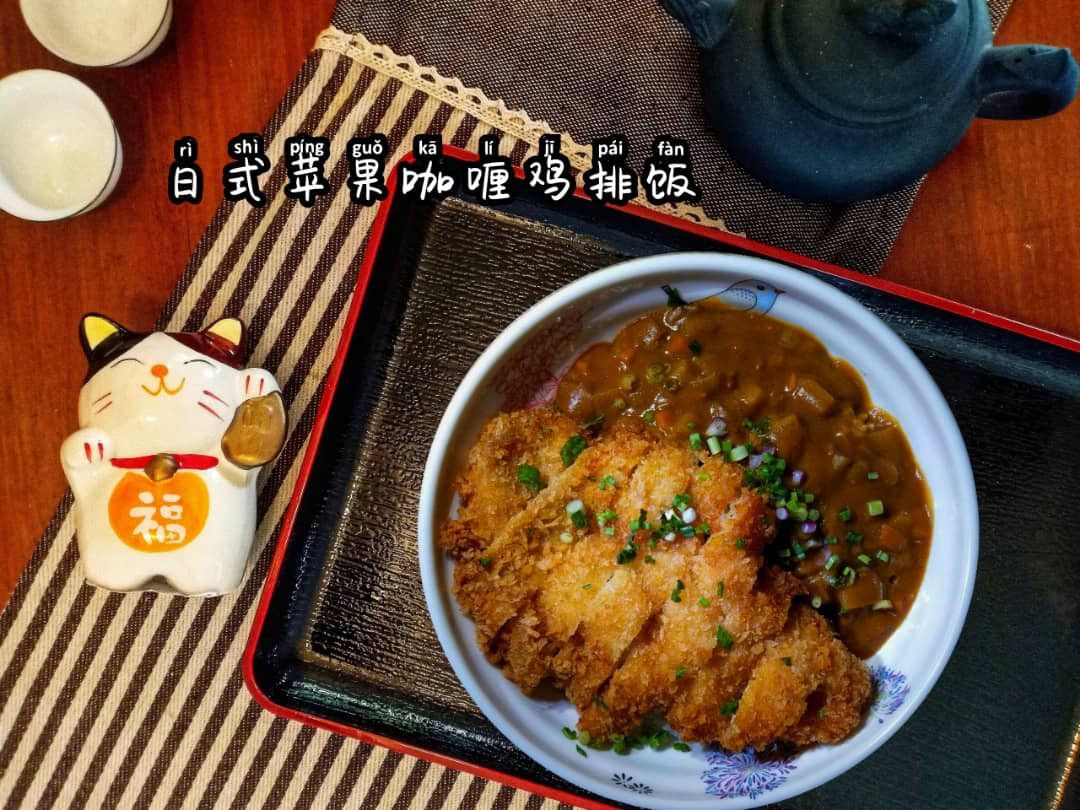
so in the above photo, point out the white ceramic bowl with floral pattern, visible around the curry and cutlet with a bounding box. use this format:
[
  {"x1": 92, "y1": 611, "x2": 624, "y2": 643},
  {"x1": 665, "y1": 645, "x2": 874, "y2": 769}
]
[{"x1": 419, "y1": 253, "x2": 978, "y2": 810}]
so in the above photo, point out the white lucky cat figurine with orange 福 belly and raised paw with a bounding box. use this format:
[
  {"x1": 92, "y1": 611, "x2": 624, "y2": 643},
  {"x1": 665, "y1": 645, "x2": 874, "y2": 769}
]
[{"x1": 60, "y1": 313, "x2": 285, "y2": 596}]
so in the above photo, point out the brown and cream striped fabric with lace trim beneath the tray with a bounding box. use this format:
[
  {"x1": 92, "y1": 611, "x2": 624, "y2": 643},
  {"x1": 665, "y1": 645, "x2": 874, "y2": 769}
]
[{"x1": 0, "y1": 29, "x2": 665, "y2": 810}]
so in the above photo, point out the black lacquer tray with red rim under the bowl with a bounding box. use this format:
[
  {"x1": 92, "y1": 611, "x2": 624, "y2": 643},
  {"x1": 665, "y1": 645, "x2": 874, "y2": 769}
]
[{"x1": 244, "y1": 149, "x2": 1080, "y2": 810}]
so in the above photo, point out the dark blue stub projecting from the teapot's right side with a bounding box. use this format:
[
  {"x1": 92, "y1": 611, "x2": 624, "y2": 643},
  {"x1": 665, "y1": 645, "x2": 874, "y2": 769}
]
[{"x1": 975, "y1": 45, "x2": 1080, "y2": 119}]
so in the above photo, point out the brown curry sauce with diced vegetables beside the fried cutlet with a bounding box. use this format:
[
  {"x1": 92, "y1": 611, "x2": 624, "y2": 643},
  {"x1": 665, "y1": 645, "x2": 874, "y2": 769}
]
[{"x1": 555, "y1": 296, "x2": 933, "y2": 658}]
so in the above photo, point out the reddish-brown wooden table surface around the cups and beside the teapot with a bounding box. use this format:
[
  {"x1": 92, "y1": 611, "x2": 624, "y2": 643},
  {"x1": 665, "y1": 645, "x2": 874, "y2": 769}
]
[{"x1": 0, "y1": 0, "x2": 1080, "y2": 605}]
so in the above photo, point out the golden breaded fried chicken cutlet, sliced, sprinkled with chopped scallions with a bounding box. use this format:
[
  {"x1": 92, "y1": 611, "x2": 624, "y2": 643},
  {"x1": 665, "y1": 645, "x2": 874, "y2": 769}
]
[{"x1": 441, "y1": 408, "x2": 870, "y2": 750}]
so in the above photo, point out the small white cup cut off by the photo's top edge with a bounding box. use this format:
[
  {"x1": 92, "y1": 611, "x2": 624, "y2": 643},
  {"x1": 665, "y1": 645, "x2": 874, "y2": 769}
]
[{"x1": 19, "y1": 0, "x2": 173, "y2": 67}]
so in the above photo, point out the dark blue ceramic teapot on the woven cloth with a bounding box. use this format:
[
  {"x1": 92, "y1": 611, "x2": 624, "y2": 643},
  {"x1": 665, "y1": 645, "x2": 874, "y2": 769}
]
[{"x1": 663, "y1": 0, "x2": 1078, "y2": 202}]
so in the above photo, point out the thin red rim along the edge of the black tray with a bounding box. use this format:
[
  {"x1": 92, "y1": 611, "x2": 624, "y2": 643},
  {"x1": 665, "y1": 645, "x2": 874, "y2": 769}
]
[{"x1": 241, "y1": 145, "x2": 1080, "y2": 810}]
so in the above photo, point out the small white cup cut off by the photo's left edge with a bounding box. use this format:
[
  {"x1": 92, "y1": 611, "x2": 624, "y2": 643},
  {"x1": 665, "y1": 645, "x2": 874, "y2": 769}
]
[{"x1": 0, "y1": 70, "x2": 123, "y2": 221}]
